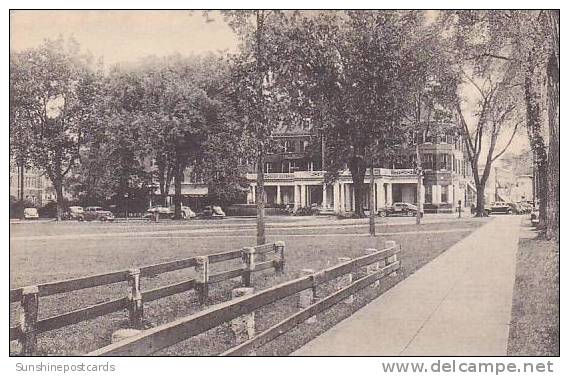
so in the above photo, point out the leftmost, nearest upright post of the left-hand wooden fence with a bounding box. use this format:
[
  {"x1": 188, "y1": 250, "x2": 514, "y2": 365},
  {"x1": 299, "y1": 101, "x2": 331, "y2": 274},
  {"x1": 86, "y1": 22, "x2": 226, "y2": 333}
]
[{"x1": 19, "y1": 286, "x2": 39, "y2": 356}]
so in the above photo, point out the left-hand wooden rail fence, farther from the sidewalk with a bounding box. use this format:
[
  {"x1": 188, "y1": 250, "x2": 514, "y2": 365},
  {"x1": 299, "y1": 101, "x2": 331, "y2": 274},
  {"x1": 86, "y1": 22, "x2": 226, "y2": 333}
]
[{"x1": 9, "y1": 241, "x2": 285, "y2": 355}]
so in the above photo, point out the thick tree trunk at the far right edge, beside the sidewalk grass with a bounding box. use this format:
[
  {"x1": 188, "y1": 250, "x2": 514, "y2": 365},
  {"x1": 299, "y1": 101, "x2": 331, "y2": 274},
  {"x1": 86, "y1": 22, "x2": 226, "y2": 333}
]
[{"x1": 540, "y1": 50, "x2": 560, "y2": 240}]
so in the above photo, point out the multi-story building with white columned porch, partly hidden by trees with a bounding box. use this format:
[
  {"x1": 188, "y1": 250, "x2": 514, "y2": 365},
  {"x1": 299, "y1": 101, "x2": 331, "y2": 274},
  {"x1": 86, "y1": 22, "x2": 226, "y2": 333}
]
[{"x1": 242, "y1": 122, "x2": 476, "y2": 212}]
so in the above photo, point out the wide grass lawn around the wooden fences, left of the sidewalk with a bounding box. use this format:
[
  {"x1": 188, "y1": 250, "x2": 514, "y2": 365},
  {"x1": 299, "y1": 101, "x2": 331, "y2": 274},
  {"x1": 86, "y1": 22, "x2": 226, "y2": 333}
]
[{"x1": 10, "y1": 219, "x2": 488, "y2": 355}]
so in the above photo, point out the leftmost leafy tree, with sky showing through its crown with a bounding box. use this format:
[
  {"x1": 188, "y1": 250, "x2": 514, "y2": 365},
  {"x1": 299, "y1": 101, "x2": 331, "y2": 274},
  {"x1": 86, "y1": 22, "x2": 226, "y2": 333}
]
[{"x1": 10, "y1": 38, "x2": 98, "y2": 219}]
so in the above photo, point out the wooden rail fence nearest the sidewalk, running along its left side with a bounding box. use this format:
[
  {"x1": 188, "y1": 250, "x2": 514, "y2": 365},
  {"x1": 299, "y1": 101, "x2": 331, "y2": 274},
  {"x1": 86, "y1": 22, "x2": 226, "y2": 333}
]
[{"x1": 86, "y1": 242, "x2": 401, "y2": 356}]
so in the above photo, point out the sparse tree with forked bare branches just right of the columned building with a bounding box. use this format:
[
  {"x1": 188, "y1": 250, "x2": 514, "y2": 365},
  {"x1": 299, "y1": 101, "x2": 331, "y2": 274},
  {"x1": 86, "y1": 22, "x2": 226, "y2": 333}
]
[{"x1": 446, "y1": 11, "x2": 523, "y2": 216}]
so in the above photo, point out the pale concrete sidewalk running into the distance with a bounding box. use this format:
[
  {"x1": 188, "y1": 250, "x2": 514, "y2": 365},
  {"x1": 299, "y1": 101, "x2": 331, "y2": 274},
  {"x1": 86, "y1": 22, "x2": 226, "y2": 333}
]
[{"x1": 291, "y1": 216, "x2": 520, "y2": 356}]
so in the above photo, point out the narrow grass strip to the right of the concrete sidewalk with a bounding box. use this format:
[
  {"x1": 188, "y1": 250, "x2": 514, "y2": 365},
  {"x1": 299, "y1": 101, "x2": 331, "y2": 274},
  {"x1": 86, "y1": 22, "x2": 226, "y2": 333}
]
[{"x1": 508, "y1": 222, "x2": 560, "y2": 356}]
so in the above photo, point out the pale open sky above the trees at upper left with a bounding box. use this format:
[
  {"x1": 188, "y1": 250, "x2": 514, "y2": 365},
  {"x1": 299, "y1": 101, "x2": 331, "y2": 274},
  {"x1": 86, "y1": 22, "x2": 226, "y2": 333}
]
[{"x1": 10, "y1": 10, "x2": 238, "y2": 66}]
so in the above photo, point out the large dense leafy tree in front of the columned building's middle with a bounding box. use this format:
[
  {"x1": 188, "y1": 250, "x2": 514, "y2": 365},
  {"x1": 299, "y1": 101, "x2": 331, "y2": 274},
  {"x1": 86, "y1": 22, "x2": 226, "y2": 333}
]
[{"x1": 278, "y1": 11, "x2": 408, "y2": 216}]
